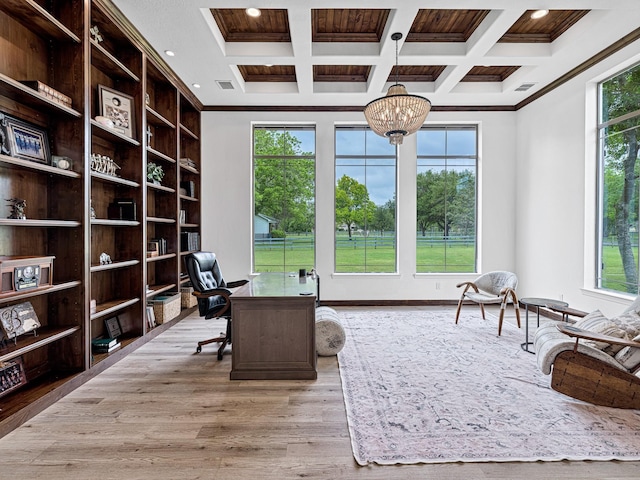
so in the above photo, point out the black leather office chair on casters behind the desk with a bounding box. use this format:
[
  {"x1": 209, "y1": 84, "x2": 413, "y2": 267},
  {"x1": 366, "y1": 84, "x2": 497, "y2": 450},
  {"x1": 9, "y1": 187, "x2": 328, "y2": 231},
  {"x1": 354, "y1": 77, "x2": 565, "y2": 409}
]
[{"x1": 184, "y1": 252, "x2": 249, "y2": 360}]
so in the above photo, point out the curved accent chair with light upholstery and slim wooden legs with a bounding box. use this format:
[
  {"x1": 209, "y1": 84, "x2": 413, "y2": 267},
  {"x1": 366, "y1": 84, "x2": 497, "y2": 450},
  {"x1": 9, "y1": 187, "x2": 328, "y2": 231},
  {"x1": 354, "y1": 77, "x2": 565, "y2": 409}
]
[{"x1": 456, "y1": 270, "x2": 520, "y2": 335}]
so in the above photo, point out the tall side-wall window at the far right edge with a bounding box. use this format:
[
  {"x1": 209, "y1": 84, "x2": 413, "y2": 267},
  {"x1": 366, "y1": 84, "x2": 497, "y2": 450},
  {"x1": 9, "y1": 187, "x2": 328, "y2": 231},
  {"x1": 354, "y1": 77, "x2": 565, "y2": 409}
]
[{"x1": 596, "y1": 65, "x2": 640, "y2": 294}]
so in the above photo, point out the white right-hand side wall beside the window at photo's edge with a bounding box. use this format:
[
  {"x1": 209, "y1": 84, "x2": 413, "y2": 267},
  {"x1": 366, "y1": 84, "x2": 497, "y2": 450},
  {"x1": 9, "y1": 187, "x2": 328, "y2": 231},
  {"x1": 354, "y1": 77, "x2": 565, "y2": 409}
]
[{"x1": 515, "y1": 42, "x2": 640, "y2": 315}]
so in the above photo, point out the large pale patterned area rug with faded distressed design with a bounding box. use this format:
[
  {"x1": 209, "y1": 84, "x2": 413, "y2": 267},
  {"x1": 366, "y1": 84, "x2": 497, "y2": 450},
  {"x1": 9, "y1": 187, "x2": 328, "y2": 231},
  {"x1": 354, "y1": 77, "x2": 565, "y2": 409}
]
[{"x1": 338, "y1": 309, "x2": 640, "y2": 465}]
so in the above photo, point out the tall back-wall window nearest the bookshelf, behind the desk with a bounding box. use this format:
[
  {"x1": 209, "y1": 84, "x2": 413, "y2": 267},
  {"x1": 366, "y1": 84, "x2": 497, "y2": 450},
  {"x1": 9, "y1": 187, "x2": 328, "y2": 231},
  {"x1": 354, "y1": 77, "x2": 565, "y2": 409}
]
[{"x1": 253, "y1": 126, "x2": 316, "y2": 272}]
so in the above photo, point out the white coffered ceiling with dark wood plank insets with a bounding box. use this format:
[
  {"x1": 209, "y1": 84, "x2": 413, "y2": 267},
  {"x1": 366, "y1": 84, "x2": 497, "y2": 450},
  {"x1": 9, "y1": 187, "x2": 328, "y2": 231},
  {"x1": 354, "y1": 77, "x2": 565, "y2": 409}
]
[{"x1": 113, "y1": 0, "x2": 640, "y2": 109}]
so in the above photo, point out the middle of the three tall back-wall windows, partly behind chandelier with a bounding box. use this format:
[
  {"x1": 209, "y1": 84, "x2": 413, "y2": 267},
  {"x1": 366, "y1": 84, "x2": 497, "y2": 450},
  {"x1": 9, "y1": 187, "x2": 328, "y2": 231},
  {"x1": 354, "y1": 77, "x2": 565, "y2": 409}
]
[{"x1": 335, "y1": 127, "x2": 396, "y2": 273}]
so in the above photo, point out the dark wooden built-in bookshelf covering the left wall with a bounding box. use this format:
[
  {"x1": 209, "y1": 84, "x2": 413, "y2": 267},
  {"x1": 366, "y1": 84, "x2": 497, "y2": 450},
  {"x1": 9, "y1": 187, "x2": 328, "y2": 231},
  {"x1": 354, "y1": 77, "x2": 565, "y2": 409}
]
[{"x1": 0, "y1": 0, "x2": 202, "y2": 436}]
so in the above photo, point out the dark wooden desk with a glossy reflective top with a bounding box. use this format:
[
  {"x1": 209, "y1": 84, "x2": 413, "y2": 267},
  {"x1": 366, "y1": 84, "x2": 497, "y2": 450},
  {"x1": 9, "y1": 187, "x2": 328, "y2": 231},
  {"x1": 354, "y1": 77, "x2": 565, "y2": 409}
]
[{"x1": 230, "y1": 273, "x2": 318, "y2": 380}]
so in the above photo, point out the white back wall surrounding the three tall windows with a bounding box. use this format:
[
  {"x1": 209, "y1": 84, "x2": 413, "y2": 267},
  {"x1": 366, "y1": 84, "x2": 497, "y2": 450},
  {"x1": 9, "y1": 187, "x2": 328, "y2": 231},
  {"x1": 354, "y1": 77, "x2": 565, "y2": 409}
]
[{"x1": 202, "y1": 111, "x2": 518, "y2": 300}]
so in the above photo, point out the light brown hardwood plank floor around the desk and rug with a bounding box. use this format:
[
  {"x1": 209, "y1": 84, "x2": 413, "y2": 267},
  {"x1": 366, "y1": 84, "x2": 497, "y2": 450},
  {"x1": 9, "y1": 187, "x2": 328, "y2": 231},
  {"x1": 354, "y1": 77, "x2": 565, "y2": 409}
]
[{"x1": 0, "y1": 309, "x2": 640, "y2": 480}]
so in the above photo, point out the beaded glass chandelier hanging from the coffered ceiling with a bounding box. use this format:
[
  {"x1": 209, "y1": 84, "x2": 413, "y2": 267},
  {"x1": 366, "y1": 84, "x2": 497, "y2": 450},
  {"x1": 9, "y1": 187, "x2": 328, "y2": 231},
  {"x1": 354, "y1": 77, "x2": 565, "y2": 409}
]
[{"x1": 364, "y1": 33, "x2": 431, "y2": 145}]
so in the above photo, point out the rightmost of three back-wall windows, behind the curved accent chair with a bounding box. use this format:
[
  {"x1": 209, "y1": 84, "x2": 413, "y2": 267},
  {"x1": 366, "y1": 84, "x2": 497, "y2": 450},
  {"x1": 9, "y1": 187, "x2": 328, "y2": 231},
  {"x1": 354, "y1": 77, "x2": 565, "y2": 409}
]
[{"x1": 416, "y1": 126, "x2": 478, "y2": 273}]
